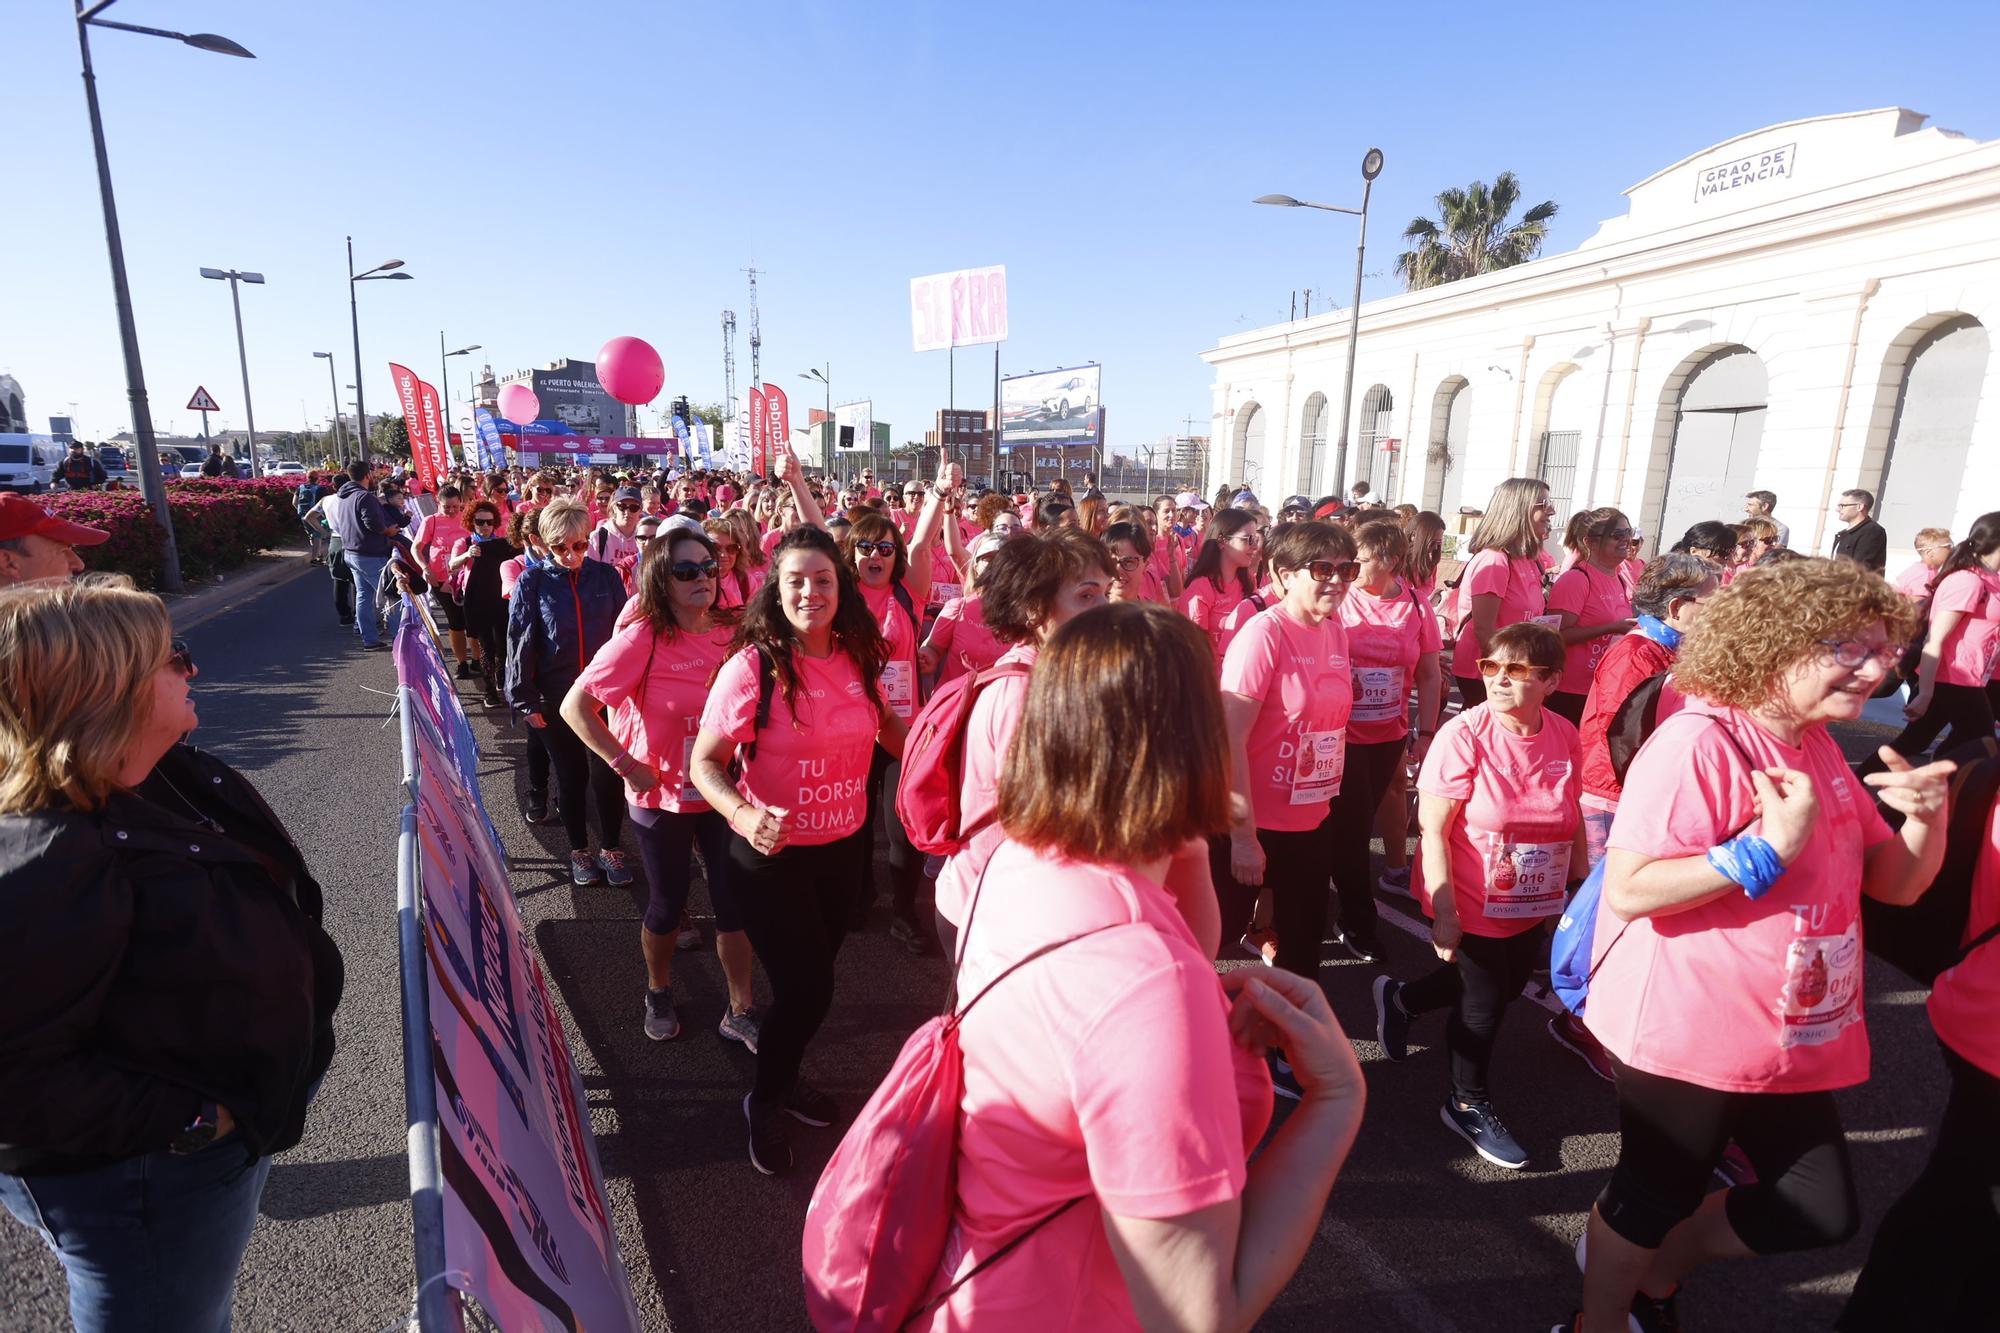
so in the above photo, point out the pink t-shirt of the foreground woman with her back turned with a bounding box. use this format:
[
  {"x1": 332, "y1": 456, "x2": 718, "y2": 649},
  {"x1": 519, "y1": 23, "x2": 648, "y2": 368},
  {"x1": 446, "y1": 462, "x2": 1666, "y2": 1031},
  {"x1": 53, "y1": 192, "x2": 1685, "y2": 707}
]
[{"x1": 918, "y1": 843, "x2": 1272, "y2": 1333}]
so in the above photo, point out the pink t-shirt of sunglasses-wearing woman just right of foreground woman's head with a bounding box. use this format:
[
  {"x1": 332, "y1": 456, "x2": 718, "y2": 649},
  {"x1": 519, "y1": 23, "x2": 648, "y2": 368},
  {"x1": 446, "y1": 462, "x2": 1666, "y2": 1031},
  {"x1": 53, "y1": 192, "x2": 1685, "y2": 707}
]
[{"x1": 1222, "y1": 606, "x2": 1354, "y2": 833}]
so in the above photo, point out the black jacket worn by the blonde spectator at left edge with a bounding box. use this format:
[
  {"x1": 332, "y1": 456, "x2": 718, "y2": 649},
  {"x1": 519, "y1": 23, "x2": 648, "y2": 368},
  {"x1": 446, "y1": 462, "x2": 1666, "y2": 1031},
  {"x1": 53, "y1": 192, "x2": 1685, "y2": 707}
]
[{"x1": 0, "y1": 745, "x2": 342, "y2": 1173}]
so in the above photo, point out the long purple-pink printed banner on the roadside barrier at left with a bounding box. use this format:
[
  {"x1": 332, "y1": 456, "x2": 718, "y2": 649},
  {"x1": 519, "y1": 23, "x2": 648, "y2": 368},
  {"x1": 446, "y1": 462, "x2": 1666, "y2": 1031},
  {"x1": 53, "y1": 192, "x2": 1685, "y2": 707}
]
[{"x1": 396, "y1": 616, "x2": 640, "y2": 1333}]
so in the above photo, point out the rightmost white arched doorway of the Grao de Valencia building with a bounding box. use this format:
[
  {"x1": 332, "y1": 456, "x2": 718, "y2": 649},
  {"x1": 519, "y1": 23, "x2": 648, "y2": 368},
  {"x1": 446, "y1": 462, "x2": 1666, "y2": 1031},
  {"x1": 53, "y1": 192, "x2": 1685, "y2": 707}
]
[{"x1": 1876, "y1": 314, "x2": 1990, "y2": 546}]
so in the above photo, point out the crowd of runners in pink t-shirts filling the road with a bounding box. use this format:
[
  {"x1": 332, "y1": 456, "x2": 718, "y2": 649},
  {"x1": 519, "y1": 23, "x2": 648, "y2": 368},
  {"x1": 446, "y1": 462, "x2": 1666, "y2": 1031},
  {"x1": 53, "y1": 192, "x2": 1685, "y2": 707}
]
[{"x1": 0, "y1": 454, "x2": 2000, "y2": 1333}]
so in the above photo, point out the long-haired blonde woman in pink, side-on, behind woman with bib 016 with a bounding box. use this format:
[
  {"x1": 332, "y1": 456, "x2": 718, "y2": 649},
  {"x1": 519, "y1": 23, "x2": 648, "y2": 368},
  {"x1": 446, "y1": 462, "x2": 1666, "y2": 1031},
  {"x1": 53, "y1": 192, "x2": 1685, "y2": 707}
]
[{"x1": 1452, "y1": 476, "x2": 1558, "y2": 709}]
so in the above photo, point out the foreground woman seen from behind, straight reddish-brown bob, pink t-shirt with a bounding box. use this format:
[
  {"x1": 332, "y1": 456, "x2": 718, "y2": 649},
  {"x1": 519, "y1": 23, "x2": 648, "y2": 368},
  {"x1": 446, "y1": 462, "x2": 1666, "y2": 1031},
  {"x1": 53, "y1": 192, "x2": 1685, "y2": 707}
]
[{"x1": 914, "y1": 602, "x2": 1364, "y2": 1333}]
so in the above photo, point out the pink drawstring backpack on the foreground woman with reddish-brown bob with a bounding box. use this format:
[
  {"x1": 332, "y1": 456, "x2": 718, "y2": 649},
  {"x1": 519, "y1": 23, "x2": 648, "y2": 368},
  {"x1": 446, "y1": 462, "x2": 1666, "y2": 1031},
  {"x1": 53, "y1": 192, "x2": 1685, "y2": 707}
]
[{"x1": 802, "y1": 868, "x2": 1130, "y2": 1333}]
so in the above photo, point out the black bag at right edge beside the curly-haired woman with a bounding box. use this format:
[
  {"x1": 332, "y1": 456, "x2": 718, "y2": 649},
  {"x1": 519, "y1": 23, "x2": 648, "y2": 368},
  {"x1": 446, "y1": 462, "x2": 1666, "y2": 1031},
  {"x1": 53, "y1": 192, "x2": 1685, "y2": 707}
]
[{"x1": 1862, "y1": 737, "x2": 2000, "y2": 987}]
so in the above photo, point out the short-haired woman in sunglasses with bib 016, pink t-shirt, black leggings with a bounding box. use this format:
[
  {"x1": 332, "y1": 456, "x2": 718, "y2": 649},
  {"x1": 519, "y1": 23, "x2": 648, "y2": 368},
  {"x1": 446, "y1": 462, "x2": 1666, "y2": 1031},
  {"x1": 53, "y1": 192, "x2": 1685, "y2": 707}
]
[{"x1": 1374, "y1": 622, "x2": 1584, "y2": 1171}]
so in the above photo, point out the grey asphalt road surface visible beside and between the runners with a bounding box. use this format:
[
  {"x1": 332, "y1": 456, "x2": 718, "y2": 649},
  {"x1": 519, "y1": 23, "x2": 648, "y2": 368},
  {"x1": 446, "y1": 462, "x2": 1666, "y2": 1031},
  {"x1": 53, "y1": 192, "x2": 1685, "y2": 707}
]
[{"x1": 0, "y1": 574, "x2": 1944, "y2": 1333}]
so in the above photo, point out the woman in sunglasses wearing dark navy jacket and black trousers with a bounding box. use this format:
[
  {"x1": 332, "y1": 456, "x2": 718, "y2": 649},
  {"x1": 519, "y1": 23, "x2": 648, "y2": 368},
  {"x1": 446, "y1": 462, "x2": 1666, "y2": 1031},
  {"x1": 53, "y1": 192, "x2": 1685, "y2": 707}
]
[{"x1": 506, "y1": 500, "x2": 632, "y2": 889}]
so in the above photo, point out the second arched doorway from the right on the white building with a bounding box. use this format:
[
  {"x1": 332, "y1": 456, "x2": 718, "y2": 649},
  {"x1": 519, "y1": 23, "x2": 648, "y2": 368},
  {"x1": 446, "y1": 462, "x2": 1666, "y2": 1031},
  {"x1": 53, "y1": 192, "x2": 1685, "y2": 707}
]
[{"x1": 1654, "y1": 346, "x2": 1770, "y2": 550}]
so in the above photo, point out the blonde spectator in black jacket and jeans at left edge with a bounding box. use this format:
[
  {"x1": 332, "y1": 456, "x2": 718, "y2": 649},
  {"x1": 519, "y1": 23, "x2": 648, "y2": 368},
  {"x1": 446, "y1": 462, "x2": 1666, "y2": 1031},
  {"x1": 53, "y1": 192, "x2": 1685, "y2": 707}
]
[{"x1": 0, "y1": 574, "x2": 342, "y2": 1333}]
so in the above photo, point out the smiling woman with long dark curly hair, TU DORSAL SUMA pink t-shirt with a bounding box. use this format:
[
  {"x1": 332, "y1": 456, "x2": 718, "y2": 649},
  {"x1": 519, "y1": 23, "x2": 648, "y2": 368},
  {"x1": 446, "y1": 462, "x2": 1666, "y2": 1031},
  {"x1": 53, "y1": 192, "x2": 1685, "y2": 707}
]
[{"x1": 688, "y1": 520, "x2": 904, "y2": 1175}]
